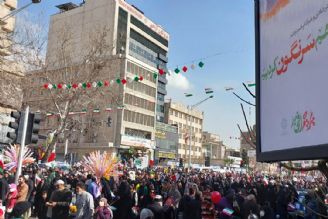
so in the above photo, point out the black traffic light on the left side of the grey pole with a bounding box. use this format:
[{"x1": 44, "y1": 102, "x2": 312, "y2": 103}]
[{"x1": 7, "y1": 111, "x2": 25, "y2": 144}]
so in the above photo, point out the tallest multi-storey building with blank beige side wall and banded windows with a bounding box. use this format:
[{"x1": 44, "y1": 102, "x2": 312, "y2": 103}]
[{"x1": 23, "y1": 0, "x2": 169, "y2": 159}]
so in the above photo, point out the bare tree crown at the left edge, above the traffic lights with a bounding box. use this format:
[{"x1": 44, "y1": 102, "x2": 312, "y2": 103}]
[{"x1": 0, "y1": 14, "x2": 46, "y2": 110}]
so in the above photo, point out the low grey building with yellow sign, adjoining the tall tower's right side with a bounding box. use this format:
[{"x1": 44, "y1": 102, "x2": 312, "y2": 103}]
[{"x1": 155, "y1": 122, "x2": 179, "y2": 165}]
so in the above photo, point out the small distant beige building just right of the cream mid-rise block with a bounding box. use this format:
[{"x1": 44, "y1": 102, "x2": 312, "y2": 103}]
[{"x1": 202, "y1": 132, "x2": 226, "y2": 165}]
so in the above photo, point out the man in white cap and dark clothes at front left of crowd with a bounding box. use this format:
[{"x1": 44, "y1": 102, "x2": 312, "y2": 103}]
[{"x1": 46, "y1": 179, "x2": 72, "y2": 219}]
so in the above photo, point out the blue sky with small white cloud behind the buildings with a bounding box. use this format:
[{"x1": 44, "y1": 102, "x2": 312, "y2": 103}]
[{"x1": 19, "y1": 0, "x2": 255, "y2": 148}]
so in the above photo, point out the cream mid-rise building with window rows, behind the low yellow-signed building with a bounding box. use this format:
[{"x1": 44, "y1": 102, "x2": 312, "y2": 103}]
[{"x1": 164, "y1": 100, "x2": 204, "y2": 163}]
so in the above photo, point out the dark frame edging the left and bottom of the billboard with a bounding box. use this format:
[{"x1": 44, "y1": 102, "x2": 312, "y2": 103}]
[{"x1": 254, "y1": 0, "x2": 328, "y2": 162}]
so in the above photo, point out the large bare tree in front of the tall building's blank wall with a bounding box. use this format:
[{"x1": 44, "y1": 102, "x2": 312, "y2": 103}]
[{"x1": 25, "y1": 23, "x2": 123, "y2": 162}]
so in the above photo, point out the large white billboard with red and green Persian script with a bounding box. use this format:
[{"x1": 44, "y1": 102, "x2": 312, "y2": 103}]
[{"x1": 255, "y1": 0, "x2": 328, "y2": 161}]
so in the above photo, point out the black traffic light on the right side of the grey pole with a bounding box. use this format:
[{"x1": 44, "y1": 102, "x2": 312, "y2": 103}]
[{"x1": 25, "y1": 113, "x2": 41, "y2": 144}]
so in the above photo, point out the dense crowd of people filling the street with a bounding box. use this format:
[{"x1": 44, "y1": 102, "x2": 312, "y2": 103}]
[{"x1": 0, "y1": 164, "x2": 327, "y2": 219}]
